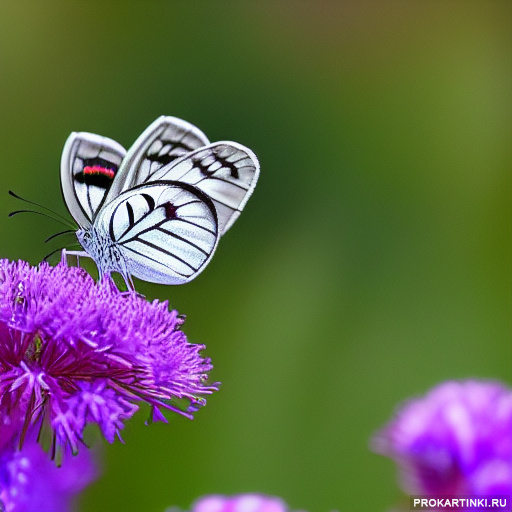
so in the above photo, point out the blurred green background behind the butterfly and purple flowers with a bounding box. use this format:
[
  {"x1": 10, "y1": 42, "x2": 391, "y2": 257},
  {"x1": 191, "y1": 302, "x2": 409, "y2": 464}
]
[{"x1": 0, "y1": 0, "x2": 512, "y2": 512}]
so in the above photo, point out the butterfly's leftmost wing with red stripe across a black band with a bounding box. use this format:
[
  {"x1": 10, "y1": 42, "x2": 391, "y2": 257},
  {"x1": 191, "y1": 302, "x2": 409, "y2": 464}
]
[{"x1": 60, "y1": 132, "x2": 126, "y2": 227}]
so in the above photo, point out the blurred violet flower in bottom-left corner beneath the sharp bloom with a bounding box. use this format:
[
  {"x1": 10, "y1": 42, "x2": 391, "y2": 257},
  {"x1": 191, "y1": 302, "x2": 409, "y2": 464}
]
[{"x1": 0, "y1": 428, "x2": 97, "y2": 512}]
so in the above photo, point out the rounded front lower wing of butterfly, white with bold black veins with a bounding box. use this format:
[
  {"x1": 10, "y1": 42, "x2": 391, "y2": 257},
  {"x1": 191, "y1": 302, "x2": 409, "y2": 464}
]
[{"x1": 94, "y1": 182, "x2": 219, "y2": 284}]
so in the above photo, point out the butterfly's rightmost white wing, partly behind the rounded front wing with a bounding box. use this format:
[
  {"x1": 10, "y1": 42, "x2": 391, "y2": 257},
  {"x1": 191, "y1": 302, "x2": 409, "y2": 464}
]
[{"x1": 150, "y1": 142, "x2": 260, "y2": 235}]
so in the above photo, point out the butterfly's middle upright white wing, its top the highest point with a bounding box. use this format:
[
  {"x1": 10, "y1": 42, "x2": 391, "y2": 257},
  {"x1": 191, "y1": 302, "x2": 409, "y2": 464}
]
[{"x1": 107, "y1": 116, "x2": 209, "y2": 201}]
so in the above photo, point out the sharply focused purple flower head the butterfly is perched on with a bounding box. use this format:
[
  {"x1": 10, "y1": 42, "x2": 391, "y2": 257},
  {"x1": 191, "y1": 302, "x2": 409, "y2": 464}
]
[{"x1": 0, "y1": 260, "x2": 217, "y2": 453}]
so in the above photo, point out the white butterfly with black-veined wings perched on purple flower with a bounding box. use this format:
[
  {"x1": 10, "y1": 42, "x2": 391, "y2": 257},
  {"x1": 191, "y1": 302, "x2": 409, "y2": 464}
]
[{"x1": 61, "y1": 116, "x2": 259, "y2": 290}]
